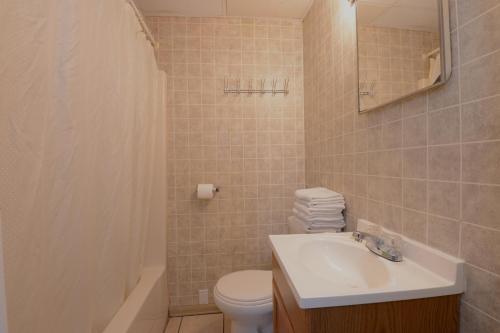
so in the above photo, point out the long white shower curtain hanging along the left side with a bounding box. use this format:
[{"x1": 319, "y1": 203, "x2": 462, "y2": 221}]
[{"x1": 0, "y1": 0, "x2": 166, "y2": 333}]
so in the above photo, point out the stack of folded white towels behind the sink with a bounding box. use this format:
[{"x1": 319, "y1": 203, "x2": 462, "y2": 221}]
[{"x1": 293, "y1": 187, "x2": 345, "y2": 231}]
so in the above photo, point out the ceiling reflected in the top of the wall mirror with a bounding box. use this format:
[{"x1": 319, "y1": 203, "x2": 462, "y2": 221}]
[{"x1": 357, "y1": 0, "x2": 438, "y2": 32}]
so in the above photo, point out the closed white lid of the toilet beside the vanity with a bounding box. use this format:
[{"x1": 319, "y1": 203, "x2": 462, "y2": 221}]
[{"x1": 216, "y1": 270, "x2": 273, "y2": 302}]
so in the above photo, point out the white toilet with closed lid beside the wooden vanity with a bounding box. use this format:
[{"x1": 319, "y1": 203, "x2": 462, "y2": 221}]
[{"x1": 214, "y1": 270, "x2": 273, "y2": 333}]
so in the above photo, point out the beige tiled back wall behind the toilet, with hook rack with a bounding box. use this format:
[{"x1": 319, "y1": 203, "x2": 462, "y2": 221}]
[{"x1": 147, "y1": 17, "x2": 305, "y2": 305}]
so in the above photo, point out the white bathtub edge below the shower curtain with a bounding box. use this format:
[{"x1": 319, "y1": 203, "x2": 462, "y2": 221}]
[{"x1": 103, "y1": 266, "x2": 168, "y2": 333}]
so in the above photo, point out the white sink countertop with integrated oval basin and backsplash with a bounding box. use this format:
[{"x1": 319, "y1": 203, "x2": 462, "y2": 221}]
[{"x1": 269, "y1": 220, "x2": 465, "y2": 309}]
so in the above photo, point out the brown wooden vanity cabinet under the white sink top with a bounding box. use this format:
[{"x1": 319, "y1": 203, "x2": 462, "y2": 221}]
[{"x1": 273, "y1": 256, "x2": 460, "y2": 333}]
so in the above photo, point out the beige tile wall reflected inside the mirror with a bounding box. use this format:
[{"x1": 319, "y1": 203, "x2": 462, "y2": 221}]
[{"x1": 358, "y1": 26, "x2": 439, "y2": 110}]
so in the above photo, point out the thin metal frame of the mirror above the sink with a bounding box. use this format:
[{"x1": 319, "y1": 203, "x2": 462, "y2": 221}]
[{"x1": 355, "y1": 0, "x2": 452, "y2": 113}]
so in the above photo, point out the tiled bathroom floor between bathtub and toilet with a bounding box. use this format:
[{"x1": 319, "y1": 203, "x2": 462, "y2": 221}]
[{"x1": 165, "y1": 313, "x2": 229, "y2": 333}]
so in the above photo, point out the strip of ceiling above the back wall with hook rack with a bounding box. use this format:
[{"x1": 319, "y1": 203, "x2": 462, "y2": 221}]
[{"x1": 135, "y1": 0, "x2": 313, "y2": 18}]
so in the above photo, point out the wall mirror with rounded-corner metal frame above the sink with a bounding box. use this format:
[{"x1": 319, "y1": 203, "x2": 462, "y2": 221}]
[{"x1": 356, "y1": 0, "x2": 451, "y2": 112}]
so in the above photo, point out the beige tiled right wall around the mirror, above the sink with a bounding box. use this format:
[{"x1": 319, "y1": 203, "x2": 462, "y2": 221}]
[{"x1": 304, "y1": 0, "x2": 500, "y2": 333}]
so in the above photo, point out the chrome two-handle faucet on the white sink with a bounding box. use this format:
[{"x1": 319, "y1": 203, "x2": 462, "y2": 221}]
[{"x1": 352, "y1": 230, "x2": 403, "y2": 262}]
